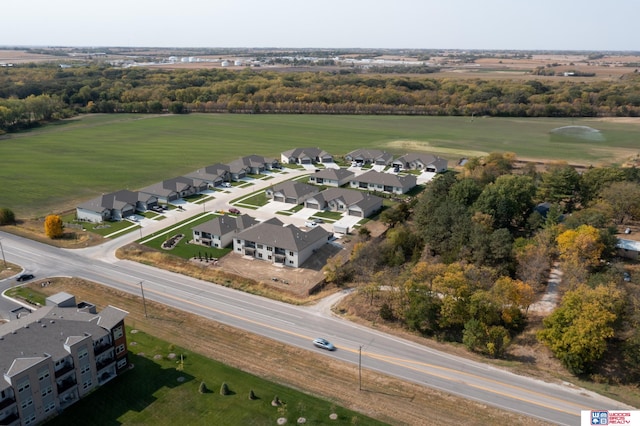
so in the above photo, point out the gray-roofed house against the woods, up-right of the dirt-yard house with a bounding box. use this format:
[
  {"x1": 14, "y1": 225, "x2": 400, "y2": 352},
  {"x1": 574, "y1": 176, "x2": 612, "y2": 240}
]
[{"x1": 304, "y1": 188, "x2": 382, "y2": 218}]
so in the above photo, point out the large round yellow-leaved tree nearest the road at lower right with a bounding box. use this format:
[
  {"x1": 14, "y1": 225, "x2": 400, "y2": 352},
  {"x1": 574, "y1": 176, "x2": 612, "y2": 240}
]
[{"x1": 537, "y1": 284, "x2": 623, "y2": 374}]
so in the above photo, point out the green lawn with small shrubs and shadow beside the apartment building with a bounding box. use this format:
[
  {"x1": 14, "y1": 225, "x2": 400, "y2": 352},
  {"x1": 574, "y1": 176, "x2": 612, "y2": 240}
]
[{"x1": 47, "y1": 329, "x2": 384, "y2": 426}]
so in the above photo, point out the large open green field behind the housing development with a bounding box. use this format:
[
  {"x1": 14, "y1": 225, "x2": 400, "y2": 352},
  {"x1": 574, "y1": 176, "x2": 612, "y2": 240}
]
[{"x1": 0, "y1": 114, "x2": 640, "y2": 217}]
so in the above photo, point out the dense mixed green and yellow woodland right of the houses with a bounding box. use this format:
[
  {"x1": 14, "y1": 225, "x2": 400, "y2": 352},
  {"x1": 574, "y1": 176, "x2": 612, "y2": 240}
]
[{"x1": 326, "y1": 153, "x2": 640, "y2": 381}]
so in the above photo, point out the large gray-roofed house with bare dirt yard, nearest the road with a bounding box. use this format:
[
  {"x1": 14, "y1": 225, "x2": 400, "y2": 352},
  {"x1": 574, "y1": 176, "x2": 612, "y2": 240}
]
[{"x1": 233, "y1": 218, "x2": 332, "y2": 268}]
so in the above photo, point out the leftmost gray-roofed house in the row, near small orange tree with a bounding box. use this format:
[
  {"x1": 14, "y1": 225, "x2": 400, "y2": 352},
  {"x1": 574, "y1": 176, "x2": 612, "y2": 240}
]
[{"x1": 76, "y1": 189, "x2": 158, "y2": 223}]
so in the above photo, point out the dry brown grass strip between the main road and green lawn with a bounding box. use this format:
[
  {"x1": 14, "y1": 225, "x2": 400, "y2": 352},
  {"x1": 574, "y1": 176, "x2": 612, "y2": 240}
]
[{"x1": 21, "y1": 278, "x2": 542, "y2": 425}]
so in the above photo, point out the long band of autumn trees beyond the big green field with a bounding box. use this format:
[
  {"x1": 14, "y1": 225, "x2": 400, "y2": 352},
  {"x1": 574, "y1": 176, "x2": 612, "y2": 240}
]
[{"x1": 0, "y1": 64, "x2": 640, "y2": 132}]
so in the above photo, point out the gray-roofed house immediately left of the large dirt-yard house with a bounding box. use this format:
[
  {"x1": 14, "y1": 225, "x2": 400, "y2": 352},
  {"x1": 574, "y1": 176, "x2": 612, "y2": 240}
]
[{"x1": 191, "y1": 214, "x2": 258, "y2": 248}]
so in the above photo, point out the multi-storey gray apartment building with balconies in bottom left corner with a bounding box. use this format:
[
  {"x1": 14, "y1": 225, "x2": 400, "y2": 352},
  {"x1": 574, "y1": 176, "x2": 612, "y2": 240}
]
[{"x1": 0, "y1": 293, "x2": 129, "y2": 426}]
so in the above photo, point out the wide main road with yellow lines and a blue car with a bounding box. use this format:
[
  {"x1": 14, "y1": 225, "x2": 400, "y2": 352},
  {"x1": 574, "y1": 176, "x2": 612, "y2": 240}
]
[{"x1": 0, "y1": 232, "x2": 629, "y2": 425}]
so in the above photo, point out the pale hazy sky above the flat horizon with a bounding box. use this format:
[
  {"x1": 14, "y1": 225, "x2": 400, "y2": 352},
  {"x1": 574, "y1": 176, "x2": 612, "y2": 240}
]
[{"x1": 0, "y1": 0, "x2": 640, "y2": 51}]
